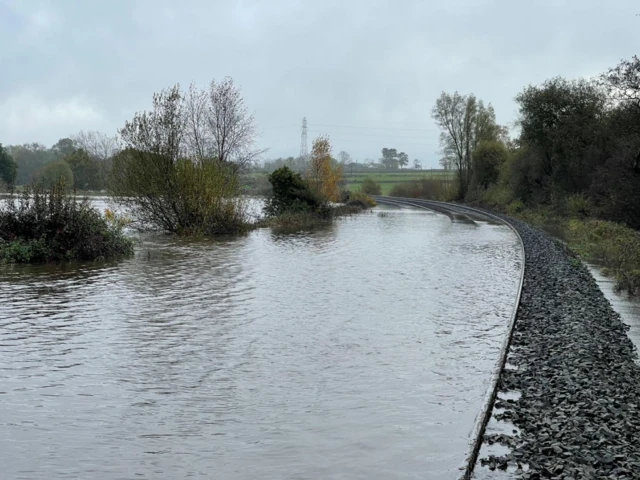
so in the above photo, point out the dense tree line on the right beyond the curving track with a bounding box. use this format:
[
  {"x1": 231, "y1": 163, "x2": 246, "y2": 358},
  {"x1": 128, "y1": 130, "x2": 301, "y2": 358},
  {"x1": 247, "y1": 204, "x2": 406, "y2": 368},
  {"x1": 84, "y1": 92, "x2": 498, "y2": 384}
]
[{"x1": 432, "y1": 56, "x2": 640, "y2": 228}]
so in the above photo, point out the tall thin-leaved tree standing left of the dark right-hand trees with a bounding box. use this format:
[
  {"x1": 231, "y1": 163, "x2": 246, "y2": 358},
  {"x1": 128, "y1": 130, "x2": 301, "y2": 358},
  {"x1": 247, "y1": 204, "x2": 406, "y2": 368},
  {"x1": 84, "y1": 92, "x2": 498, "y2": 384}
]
[{"x1": 431, "y1": 92, "x2": 499, "y2": 198}]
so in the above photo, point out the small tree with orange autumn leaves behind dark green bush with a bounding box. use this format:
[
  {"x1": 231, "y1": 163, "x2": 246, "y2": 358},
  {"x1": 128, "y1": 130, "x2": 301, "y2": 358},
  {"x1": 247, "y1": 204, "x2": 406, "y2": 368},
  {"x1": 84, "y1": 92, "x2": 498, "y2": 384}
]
[{"x1": 305, "y1": 136, "x2": 343, "y2": 202}]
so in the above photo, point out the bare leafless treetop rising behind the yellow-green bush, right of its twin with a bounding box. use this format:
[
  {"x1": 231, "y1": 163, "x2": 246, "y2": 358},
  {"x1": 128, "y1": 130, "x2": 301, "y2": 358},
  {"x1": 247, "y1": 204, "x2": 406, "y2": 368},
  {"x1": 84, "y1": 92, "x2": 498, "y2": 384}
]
[{"x1": 184, "y1": 77, "x2": 264, "y2": 171}]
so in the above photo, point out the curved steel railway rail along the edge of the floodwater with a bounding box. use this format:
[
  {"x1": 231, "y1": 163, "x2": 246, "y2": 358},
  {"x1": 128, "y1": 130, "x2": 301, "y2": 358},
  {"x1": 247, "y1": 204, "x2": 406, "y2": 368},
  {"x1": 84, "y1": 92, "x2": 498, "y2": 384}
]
[{"x1": 373, "y1": 195, "x2": 525, "y2": 480}]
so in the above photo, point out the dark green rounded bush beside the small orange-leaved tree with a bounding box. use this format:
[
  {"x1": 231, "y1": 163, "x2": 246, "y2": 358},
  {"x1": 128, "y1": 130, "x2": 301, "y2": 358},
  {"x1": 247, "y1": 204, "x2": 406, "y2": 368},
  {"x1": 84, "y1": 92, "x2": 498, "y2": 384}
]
[{"x1": 264, "y1": 166, "x2": 325, "y2": 217}]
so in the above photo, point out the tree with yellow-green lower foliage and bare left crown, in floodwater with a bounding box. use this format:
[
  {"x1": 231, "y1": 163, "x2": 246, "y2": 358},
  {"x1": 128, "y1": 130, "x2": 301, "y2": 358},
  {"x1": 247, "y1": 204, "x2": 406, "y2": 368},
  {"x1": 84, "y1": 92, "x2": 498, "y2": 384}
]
[{"x1": 110, "y1": 85, "x2": 247, "y2": 235}]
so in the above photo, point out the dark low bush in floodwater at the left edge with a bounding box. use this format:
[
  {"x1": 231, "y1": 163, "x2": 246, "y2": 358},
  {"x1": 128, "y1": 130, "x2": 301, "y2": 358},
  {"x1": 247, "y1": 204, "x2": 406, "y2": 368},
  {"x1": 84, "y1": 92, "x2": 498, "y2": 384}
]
[{"x1": 0, "y1": 181, "x2": 133, "y2": 263}]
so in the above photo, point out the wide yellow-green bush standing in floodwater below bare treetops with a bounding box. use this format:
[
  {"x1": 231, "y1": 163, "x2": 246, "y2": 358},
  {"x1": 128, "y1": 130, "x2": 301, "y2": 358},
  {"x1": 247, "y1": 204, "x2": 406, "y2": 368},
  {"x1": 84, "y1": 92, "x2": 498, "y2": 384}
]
[{"x1": 111, "y1": 149, "x2": 251, "y2": 236}]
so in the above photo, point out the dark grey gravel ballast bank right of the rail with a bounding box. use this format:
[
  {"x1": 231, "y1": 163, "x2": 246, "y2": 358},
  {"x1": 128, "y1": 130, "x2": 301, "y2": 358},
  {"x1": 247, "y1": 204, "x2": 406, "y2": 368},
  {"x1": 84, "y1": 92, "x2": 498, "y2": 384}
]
[{"x1": 480, "y1": 219, "x2": 640, "y2": 480}]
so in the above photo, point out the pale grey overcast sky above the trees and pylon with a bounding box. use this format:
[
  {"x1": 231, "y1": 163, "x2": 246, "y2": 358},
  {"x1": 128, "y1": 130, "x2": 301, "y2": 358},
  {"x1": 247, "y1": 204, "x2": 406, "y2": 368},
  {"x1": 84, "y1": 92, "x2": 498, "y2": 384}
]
[{"x1": 0, "y1": 0, "x2": 640, "y2": 167}]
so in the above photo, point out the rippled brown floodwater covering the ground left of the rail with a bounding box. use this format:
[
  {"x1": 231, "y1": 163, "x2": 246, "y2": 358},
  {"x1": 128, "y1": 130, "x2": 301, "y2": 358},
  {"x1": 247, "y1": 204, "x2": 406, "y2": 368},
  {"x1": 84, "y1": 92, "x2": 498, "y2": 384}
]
[{"x1": 0, "y1": 201, "x2": 521, "y2": 480}]
